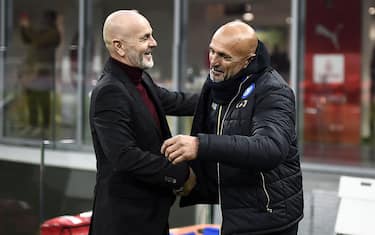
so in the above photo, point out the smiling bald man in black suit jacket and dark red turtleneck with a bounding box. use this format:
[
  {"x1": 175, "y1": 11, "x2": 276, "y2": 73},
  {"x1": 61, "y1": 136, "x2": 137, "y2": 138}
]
[{"x1": 90, "y1": 10, "x2": 198, "y2": 235}]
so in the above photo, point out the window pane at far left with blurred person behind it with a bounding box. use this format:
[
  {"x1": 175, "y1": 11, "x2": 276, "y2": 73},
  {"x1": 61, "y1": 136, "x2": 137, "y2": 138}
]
[{"x1": 2, "y1": 0, "x2": 78, "y2": 145}]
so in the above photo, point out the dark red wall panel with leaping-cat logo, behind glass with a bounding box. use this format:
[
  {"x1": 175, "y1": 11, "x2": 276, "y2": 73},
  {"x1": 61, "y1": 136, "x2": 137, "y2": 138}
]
[{"x1": 301, "y1": 0, "x2": 361, "y2": 144}]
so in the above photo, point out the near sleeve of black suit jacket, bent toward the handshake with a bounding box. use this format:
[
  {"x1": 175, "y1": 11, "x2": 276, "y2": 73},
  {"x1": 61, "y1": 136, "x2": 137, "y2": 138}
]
[{"x1": 91, "y1": 85, "x2": 189, "y2": 188}]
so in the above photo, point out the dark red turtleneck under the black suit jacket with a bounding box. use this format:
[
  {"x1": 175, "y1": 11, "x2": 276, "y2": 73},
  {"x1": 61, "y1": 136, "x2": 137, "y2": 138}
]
[{"x1": 116, "y1": 58, "x2": 160, "y2": 128}]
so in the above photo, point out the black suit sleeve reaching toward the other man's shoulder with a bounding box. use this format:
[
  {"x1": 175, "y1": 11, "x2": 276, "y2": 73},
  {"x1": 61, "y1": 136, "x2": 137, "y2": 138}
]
[{"x1": 156, "y1": 86, "x2": 199, "y2": 116}]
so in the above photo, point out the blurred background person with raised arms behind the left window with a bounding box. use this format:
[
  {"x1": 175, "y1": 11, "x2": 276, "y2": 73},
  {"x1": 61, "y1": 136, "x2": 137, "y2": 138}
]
[{"x1": 19, "y1": 10, "x2": 61, "y2": 137}]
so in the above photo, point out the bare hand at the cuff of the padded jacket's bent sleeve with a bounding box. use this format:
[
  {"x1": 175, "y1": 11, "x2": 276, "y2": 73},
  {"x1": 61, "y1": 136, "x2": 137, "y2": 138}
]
[{"x1": 161, "y1": 135, "x2": 199, "y2": 164}]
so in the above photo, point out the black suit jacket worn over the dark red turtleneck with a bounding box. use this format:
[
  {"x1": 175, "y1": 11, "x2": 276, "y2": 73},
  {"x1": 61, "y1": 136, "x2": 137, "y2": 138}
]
[{"x1": 90, "y1": 59, "x2": 198, "y2": 235}]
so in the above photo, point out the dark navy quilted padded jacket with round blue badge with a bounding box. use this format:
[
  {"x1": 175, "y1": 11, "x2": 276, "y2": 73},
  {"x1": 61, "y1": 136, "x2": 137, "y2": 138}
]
[{"x1": 180, "y1": 42, "x2": 303, "y2": 235}]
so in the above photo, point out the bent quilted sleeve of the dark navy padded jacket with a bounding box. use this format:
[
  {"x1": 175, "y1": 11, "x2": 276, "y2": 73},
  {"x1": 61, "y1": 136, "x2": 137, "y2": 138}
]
[{"x1": 198, "y1": 81, "x2": 296, "y2": 170}]
